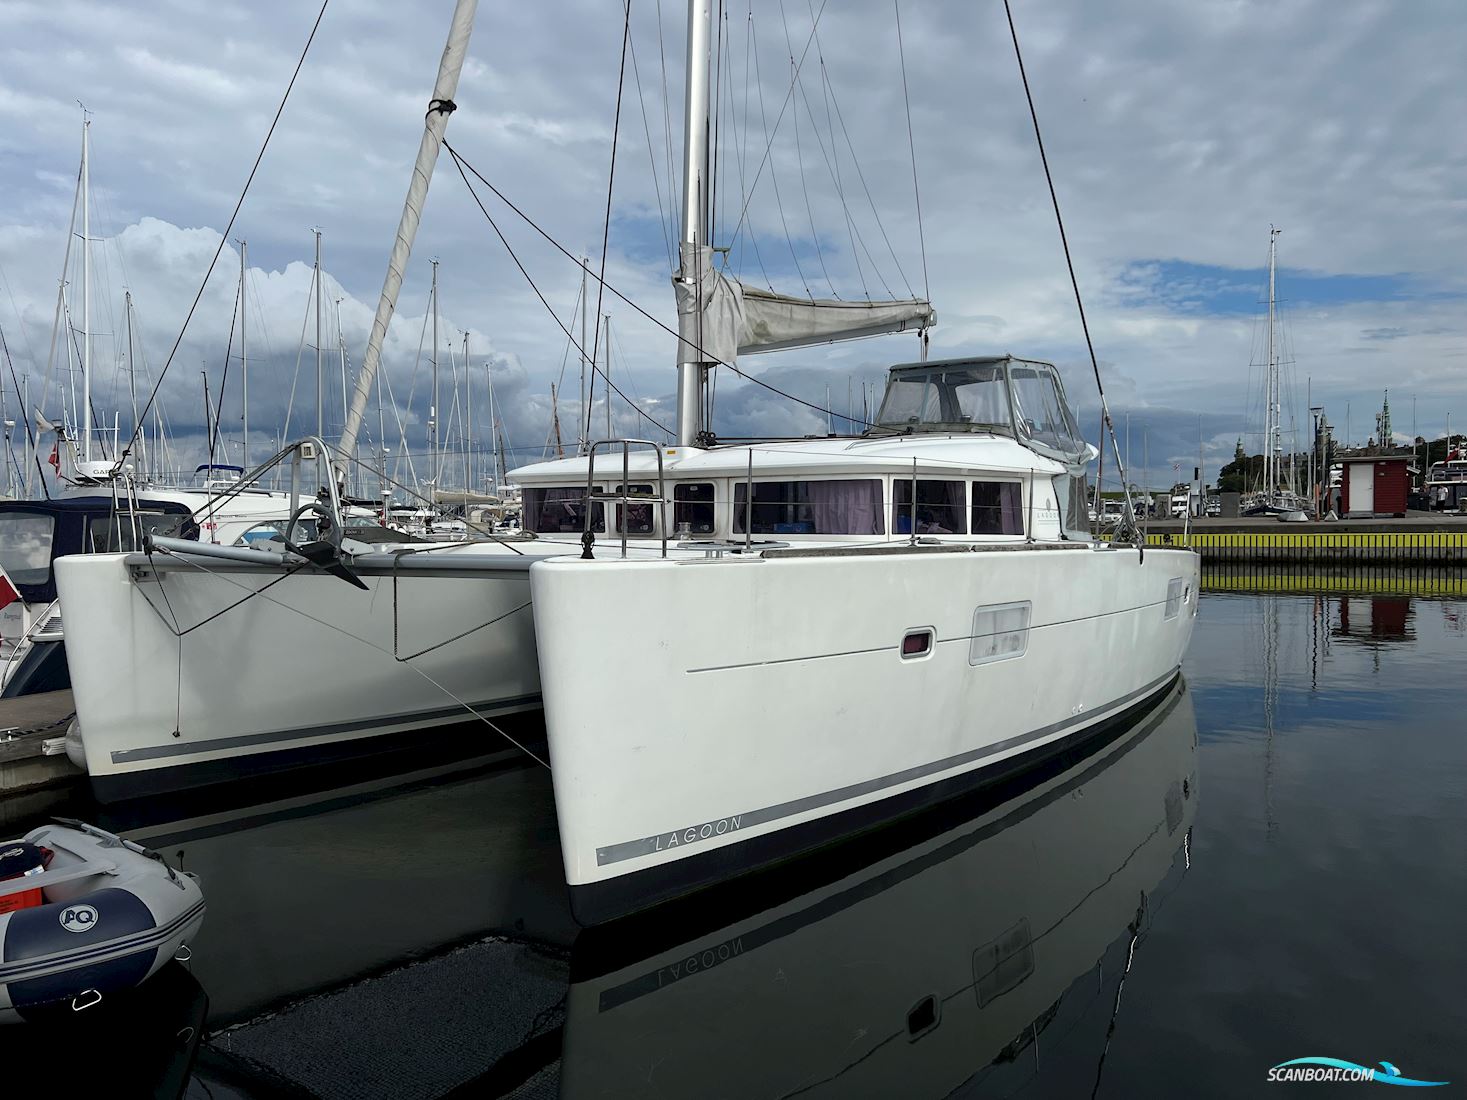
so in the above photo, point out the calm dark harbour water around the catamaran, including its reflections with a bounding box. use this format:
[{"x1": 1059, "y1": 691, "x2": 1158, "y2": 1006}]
[{"x1": 0, "y1": 594, "x2": 1467, "y2": 1097}]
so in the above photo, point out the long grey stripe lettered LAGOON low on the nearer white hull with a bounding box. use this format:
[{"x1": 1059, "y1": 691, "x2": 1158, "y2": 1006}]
[{"x1": 596, "y1": 669, "x2": 1177, "y2": 867}]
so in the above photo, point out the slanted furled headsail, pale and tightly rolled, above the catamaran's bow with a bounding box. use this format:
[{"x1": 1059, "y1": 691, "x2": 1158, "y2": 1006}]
[{"x1": 340, "y1": 0, "x2": 478, "y2": 478}]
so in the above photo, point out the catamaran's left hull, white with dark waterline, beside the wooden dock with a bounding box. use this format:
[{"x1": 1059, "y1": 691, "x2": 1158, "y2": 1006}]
[{"x1": 56, "y1": 554, "x2": 540, "y2": 801}]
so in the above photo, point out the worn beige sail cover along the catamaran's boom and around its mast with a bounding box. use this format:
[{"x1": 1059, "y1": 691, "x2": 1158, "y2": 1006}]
[{"x1": 672, "y1": 243, "x2": 937, "y2": 364}]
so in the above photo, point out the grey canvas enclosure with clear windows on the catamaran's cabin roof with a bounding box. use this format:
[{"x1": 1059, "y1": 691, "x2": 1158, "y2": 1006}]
[{"x1": 876, "y1": 355, "x2": 1094, "y2": 466}]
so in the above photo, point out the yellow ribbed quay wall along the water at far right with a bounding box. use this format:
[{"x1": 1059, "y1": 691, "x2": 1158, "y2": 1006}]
[{"x1": 1120, "y1": 512, "x2": 1467, "y2": 566}]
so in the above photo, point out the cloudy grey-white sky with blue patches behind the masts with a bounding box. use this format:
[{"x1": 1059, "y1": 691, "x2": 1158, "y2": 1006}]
[{"x1": 0, "y1": 0, "x2": 1467, "y2": 484}]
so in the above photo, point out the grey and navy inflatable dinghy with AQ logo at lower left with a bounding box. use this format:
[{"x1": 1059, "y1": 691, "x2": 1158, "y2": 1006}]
[{"x1": 0, "y1": 818, "x2": 204, "y2": 1024}]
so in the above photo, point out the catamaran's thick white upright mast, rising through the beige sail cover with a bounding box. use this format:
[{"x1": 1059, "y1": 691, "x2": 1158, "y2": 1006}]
[{"x1": 676, "y1": 0, "x2": 713, "y2": 447}]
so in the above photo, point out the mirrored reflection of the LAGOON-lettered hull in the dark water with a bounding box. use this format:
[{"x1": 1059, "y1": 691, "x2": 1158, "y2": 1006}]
[{"x1": 560, "y1": 681, "x2": 1197, "y2": 1099}]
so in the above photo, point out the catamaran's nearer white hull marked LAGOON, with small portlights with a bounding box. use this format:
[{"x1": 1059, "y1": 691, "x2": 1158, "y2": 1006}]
[{"x1": 531, "y1": 544, "x2": 1199, "y2": 924}]
